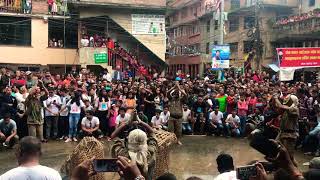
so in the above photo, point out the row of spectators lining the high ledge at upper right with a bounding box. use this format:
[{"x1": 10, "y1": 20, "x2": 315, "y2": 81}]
[{"x1": 276, "y1": 9, "x2": 320, "y2": 25}]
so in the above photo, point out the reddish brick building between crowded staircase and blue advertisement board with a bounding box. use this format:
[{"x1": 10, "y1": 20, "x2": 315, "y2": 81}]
[{"x1": 166, "y1": 0, "x2": 219, "y2": 76}]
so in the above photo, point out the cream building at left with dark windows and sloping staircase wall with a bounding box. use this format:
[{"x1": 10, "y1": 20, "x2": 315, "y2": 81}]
[{"x1": 0, "y1": 0, "x2": 166, "y2": 72}]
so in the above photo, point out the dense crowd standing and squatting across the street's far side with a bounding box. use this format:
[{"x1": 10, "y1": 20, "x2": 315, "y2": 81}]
[{"x1": 0, "y1": 68, "x2": 320, "y2": 179}]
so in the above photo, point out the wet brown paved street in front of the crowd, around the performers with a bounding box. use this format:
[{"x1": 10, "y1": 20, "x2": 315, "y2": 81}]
[{"x1": 0, "y1": 136, "x2": 310, "y2": 179}]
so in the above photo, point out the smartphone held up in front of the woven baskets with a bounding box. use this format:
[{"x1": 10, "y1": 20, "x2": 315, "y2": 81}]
[{"x1": 93, "y1": 159, "x2": 119, "y2": 172}]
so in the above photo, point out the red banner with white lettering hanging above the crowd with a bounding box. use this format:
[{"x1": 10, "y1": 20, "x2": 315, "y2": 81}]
[{"x1": 277, "y1": 48, "x2": 320, "y2": 67}]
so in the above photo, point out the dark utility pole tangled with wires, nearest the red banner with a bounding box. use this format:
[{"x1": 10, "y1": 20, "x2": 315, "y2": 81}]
[{"x1": 254, "y1": 0, "x2": 263, "y2": 69}]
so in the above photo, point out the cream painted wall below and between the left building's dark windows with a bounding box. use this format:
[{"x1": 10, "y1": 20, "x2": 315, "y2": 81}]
[{"x1": 0, "y1": 19, "x2": 78, "y2": 65}]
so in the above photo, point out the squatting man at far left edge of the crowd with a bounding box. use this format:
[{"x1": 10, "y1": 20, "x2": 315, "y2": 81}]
[{"x1": 0, "y1": 113, "x2": 19, "y2": 148}]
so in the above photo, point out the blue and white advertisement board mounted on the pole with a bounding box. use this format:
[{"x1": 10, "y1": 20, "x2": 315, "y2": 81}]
[{"x1": 212, "y1": 45, "x2": 230, "y2": 69}]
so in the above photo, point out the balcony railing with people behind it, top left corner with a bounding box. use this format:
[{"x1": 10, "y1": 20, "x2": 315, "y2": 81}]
[{"x1": 0, "y1": 0, "x2": 32, "y2": 14}]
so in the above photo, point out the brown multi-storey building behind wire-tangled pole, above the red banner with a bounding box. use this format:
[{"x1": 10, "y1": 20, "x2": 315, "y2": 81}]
[{"x1": 224, "y1": 0, "x2": 320, "y2": 69}]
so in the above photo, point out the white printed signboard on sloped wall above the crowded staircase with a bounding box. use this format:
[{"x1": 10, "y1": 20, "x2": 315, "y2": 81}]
[{"x1": 131, "y1": 14, "x2": 165, "y2": 34}]
